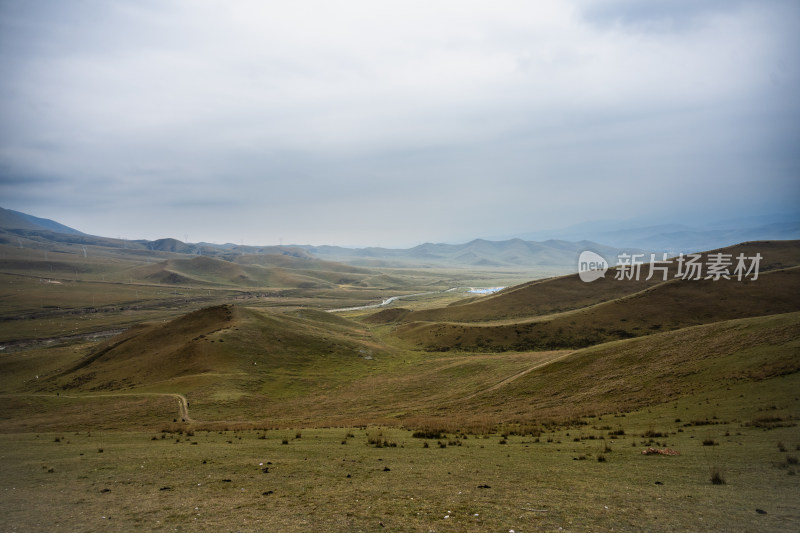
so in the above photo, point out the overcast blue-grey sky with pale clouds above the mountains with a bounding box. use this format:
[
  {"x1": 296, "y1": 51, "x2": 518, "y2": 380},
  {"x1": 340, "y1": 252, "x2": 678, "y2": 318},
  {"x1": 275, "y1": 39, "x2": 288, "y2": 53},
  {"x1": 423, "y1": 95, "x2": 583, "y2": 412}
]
[{"x1": 0, "y1": 0, "x2": 800, "y2": 247}]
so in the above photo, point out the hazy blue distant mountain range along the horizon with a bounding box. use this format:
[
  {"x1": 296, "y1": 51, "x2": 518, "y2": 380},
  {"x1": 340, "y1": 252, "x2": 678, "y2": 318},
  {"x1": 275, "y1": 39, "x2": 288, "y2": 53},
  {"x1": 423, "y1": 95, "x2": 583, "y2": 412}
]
[{"x1": 0, "y1": 204, "x2": 800, "y2": 274}]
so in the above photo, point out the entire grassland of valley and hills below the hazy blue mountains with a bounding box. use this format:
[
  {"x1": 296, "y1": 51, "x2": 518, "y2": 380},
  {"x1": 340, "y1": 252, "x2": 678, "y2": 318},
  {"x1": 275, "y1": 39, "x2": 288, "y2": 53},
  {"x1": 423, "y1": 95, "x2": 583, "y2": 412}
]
[{"x1": 0, "y1": 239, "x2": 800, "y2": 532}]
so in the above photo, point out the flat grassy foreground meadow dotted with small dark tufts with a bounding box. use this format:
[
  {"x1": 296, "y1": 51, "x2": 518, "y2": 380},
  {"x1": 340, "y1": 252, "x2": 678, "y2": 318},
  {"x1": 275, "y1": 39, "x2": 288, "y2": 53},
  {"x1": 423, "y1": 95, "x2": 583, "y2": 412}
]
[{"x1": 0, "y1": 376, "x2": 800, "y2": 532}]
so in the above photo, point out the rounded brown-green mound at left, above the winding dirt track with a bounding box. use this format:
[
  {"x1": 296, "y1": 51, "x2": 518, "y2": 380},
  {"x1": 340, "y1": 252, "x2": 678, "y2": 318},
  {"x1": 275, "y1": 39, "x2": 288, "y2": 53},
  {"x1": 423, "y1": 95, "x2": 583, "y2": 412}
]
[{"x1": 40, "y1": 305, "x2": 384, "y2": 395}]
